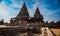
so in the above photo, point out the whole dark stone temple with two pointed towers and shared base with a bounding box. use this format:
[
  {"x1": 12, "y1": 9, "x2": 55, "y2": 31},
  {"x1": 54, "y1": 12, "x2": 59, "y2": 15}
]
[{"x1": 10, "y1": 3, "x2": 44, "y2": 26}]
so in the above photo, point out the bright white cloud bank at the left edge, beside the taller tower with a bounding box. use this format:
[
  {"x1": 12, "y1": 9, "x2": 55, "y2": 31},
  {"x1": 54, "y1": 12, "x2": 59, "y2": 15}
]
[{"x1": 0, "y1": 1, "x2": 17, "y2": 22}]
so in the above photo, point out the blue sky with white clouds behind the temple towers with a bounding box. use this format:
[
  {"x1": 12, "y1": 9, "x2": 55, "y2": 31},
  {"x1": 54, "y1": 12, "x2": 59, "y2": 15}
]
[{"x1": 0, "y1": 0, "x2": 60, "y2": 22}]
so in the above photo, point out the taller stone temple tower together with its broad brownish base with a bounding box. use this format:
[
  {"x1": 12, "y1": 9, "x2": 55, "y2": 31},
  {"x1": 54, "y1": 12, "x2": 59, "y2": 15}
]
[{"x1": 10, "y1": 2, "x2": 29, "y2": 26}]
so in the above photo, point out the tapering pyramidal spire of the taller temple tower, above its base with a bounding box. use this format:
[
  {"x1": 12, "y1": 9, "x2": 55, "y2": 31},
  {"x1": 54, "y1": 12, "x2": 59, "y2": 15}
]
[{"x1": 17, "y1": 2, "x2": 29, "y2": 18}]
